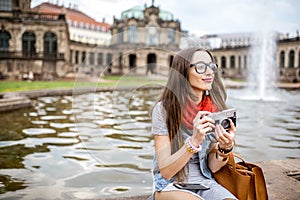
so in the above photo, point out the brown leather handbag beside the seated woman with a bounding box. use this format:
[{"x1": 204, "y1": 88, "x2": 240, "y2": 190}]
[{"x1": 213, "y1": 152, "x2": 268, "y2": 200}]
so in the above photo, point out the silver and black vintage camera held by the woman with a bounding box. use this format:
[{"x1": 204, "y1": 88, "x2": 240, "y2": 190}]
[{"x1": 208, "y1": 108, "x2": 236, "y2": 132}]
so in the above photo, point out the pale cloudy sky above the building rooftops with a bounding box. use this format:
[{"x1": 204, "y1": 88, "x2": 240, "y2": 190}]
[{"x1": 31, "y1": 0, "x2": 300, "y2": 37}]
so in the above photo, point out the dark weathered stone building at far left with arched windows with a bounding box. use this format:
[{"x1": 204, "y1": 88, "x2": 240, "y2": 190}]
[{"x1": 0, "y1": 0, "x2": 70, "y2": 79}]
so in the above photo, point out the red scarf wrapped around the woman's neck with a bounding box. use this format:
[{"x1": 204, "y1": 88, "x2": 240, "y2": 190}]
[{"x1": 181, "y1": 95, "x2": 218, "y2": 130}]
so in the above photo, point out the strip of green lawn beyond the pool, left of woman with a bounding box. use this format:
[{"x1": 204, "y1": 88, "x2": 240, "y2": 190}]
[{"x1": 0, "y1": 76, "x2": 165, "y2": 92}]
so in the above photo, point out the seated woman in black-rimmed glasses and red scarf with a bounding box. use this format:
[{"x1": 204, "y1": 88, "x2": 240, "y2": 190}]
[{"x1": 152, "y1": 48, "x2": 236, "y2": 200}]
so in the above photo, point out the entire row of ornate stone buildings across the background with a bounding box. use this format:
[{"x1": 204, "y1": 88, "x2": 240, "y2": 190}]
[{"x1": 0, "y1": 0, "x2": 300, "y2": 82}]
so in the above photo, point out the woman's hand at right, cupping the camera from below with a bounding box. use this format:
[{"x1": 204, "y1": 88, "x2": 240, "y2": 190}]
[{"x1": 215, "y1": 119, "x2": 236, "y2": 149}]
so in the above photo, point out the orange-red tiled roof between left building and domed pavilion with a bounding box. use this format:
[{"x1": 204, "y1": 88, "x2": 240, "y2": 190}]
[{"x1": 32, "y1": 2, "x2": 110, "y2": 32}]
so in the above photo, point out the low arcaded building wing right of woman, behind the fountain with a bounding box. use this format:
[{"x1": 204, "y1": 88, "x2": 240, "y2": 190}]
[{"x1": 182, "y1": 32, "x2": 300, "y2": 82}]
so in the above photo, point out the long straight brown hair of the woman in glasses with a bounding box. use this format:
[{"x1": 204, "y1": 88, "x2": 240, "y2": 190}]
[{"x1": 159, "y1": 48, "x2": 226, "y2": 181}]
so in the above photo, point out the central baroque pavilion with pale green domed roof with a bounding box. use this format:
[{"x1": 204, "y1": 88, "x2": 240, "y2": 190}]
[{"x1": 106, "y1": 2, "x2": 182, "y2": 75}]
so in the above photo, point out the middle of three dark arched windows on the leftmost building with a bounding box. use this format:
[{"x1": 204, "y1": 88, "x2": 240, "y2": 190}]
[{"x1": 22, "y1": 31, "x2": 35, "y2": 57}]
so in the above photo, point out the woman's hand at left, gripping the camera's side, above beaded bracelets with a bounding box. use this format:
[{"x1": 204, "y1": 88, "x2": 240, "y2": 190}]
[{"x1": 191, "y1": 111, "x2": 215, "y2": 147}]
